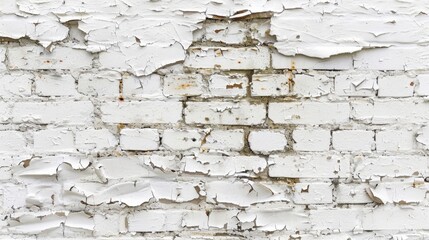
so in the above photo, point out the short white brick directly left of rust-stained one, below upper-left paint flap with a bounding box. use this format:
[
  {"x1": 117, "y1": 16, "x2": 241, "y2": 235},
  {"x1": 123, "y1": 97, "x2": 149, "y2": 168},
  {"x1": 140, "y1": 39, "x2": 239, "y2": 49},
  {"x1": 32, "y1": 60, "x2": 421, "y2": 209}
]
[{"x1": 122, "y1": 74, "x2": 164, "y2": 99}]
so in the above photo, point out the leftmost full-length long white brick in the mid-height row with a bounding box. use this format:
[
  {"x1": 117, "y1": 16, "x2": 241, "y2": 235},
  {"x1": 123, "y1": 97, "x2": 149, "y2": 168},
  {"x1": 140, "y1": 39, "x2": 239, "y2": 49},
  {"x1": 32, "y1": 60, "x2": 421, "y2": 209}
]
[{"x1": 11, "y1": 101, "x2": 94, "y2": 125}]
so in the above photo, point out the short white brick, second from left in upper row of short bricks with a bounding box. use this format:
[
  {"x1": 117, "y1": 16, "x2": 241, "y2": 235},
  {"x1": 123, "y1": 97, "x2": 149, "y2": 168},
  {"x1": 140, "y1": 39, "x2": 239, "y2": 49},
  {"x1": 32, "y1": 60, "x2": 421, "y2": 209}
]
[{"x1": 35, "y1": 74, "x2": 77, "y2": 96}]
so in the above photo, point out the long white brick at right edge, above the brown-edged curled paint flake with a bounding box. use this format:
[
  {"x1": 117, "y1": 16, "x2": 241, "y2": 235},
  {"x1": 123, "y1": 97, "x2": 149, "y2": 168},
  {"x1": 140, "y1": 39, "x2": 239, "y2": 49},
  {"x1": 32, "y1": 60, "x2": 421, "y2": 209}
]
[{"x1": 353, "y1": 155, "x2": 429, "y2": 180}]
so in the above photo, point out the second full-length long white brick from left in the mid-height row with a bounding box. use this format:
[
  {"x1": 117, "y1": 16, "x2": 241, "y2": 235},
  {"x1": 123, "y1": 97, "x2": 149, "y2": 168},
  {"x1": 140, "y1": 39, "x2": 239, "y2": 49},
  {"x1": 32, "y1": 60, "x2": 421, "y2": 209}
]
[{"x1": 101, "y1": 101, "x2": 182, "y2": 123}]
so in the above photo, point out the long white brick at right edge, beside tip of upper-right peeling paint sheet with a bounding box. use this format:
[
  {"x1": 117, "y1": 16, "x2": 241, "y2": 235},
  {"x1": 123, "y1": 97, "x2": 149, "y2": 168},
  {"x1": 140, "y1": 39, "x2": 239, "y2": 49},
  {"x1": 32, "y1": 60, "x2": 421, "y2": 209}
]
[{"x1": 353, "y1": 46, "x2": 429, "y2": 70}]
